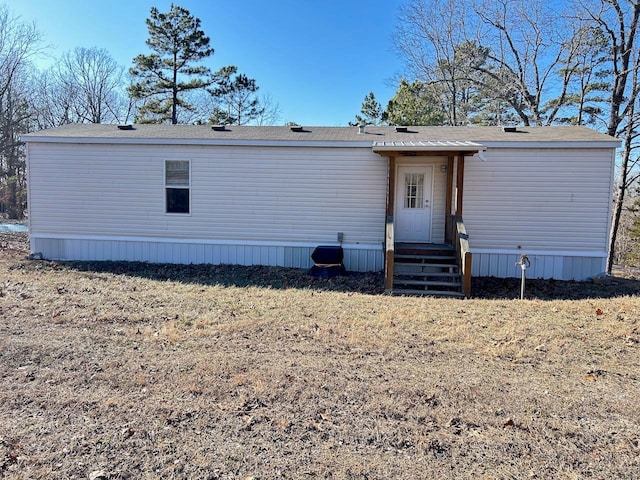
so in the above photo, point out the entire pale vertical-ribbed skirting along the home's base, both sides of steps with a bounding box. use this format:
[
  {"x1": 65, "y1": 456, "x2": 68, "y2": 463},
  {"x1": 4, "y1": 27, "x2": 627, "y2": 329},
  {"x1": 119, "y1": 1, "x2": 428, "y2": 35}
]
[{"x1": 30, "y1": 234, "x2": 606, "y2": 280}]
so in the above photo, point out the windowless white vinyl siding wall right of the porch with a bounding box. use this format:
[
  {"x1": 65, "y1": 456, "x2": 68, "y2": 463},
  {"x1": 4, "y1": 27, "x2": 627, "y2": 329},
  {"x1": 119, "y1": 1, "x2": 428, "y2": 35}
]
[{"x1": 463, "y1": 148, "x2": 613, "y2": 254}]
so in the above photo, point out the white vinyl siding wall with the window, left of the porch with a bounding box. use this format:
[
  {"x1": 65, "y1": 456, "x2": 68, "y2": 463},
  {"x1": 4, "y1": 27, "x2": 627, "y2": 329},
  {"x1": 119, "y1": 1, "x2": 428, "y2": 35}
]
[{"x1": 29, "y1": 143, "x2": 387, "y2": 245}]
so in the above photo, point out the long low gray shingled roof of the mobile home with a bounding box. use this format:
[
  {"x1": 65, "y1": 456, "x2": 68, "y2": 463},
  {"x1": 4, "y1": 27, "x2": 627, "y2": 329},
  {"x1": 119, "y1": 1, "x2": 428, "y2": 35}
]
[{"x1": 23, "y1": 124, "x2": 619, "y2": 145}]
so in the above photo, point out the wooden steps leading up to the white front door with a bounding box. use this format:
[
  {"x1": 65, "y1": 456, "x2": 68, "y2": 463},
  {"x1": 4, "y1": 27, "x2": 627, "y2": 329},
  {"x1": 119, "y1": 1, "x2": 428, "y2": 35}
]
[{"x1": 392, "y1": 244, "x2": 464, "y2": 297}]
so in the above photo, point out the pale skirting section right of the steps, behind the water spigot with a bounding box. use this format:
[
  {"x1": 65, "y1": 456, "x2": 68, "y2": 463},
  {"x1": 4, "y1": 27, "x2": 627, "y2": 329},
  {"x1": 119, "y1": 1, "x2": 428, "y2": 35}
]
[{"x1": 471, "y1": 252, "x2": 606, "y2": 280}]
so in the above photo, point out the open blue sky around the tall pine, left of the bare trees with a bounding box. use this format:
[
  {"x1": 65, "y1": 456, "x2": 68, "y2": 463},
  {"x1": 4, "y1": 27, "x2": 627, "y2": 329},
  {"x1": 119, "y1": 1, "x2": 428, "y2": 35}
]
[{"x1": 7, "y1": 0, "x2": 402, "y2": 126}]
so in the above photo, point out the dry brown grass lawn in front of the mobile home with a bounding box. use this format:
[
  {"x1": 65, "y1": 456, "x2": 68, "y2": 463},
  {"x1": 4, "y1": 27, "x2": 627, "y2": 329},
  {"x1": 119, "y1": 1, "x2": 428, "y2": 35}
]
[{"x1": 0, "y1": 234, "x2": 640, "y2": 479}]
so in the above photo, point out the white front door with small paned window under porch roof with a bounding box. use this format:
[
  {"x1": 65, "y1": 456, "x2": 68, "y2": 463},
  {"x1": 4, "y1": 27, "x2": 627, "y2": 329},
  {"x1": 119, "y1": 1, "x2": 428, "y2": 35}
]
[{"x1": 394, "y1": 165, "x2": 433, "y2": 242}]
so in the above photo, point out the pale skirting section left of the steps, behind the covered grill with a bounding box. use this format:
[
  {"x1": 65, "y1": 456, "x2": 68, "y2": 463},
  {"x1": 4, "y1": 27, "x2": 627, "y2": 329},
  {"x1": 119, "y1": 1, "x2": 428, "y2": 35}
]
[{"x1": 31, "y1": 235, "x2": 384, "y2": 272}]
